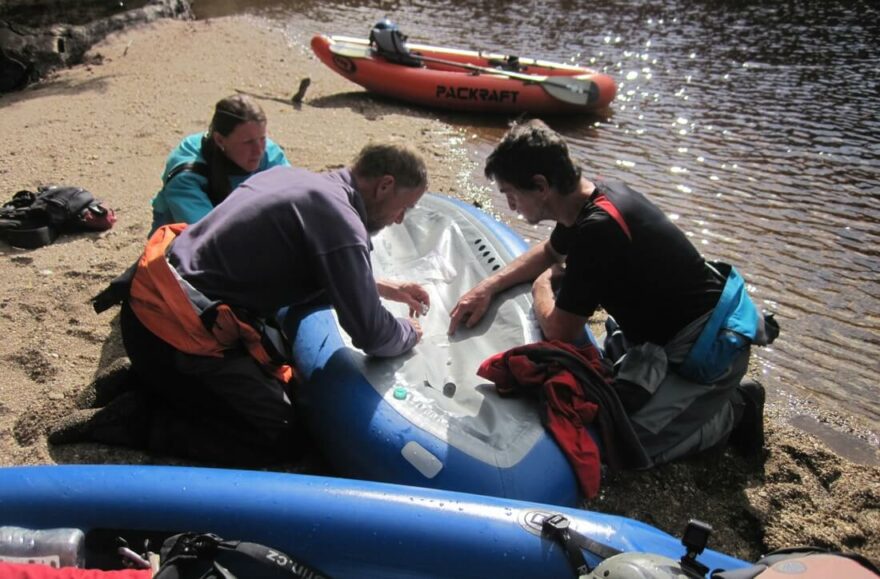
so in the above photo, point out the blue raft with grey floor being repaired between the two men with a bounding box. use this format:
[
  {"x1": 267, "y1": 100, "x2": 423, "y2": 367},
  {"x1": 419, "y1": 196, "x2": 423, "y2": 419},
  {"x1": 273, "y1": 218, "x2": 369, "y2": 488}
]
[{"x1": 285, "y1": 195, "x2": 579, "y2": 505}]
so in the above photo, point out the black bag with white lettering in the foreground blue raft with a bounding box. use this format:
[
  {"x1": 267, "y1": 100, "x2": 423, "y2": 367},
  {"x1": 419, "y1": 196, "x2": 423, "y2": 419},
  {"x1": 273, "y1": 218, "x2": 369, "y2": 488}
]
[{"x1": 153, "y1": 533, "x2": 329, "y2": 579}]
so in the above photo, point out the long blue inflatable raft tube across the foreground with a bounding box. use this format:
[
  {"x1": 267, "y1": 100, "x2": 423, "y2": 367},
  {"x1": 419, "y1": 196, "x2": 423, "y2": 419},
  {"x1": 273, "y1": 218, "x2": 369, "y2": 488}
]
[{"x1": 0, "y1": 465, "x2": 746, "y2": 579}]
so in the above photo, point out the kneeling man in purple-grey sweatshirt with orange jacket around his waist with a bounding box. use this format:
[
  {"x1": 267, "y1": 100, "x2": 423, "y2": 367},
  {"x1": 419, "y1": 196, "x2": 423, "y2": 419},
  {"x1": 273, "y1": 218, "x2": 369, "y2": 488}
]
[{"x1": 49, "y1": 145, "x2": 429, "y2": 466}]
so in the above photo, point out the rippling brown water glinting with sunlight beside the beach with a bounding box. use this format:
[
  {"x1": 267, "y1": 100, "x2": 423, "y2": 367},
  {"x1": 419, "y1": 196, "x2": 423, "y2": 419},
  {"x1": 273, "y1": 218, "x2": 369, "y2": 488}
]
[{"x1": 194, "y1": 0, "x2": 880, "y2": 455}]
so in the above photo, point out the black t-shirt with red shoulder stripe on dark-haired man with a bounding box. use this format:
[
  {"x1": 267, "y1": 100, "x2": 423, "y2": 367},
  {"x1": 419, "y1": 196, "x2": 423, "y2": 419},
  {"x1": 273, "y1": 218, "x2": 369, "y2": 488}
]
[{"x1": 550, "y1": 182, "x2": 723, "y2": 345}]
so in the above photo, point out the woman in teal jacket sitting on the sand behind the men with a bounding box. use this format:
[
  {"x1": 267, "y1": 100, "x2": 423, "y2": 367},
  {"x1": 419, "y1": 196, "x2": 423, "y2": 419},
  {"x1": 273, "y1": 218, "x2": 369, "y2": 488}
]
[{"x1": 150, "y1": 94, "x2": 290, "y2": 234}]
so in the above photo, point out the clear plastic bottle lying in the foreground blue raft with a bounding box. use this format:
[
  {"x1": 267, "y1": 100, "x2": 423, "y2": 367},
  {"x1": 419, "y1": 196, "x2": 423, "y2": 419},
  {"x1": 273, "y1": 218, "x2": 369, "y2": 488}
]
[{"x1": 0, "y1": 527, "x2": 85, "y2": 568}]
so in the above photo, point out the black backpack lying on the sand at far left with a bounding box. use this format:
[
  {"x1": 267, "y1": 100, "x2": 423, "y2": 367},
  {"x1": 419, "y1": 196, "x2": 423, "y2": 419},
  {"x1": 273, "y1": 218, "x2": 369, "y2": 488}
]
[{"x1": 0, "y1": 186, "x2": 116, "y2": 249}]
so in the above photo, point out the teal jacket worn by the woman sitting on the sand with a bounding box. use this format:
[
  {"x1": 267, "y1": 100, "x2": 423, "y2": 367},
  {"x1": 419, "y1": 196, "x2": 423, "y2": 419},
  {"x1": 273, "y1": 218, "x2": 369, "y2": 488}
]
[{"x1": 150, "y1": 133, "x2": 290, "y2": 235}]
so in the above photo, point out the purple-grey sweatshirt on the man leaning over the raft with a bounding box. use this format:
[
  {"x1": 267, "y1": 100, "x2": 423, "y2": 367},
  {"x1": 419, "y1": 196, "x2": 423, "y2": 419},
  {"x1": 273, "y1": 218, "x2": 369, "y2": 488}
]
[{"x1": 169, "y1": 167, "x2": 417, "y2": 356}]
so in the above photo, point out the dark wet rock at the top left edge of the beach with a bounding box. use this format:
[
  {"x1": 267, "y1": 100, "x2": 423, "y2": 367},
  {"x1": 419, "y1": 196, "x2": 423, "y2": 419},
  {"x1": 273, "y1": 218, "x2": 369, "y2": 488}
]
[{"x1": 0, "y1": 0, "x2": 192, "y2": 92}]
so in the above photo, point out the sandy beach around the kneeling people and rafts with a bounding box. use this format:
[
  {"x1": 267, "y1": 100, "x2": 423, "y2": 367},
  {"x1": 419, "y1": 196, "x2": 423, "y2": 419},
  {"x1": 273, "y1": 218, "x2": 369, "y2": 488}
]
[{"x1": 0, "y1": 17, "x2": 880, "y2": 561}]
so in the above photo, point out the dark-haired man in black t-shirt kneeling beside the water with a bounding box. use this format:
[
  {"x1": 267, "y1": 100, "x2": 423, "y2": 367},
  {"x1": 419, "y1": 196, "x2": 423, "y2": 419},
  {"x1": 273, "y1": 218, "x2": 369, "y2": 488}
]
[{"x1": 449, "y1": 120, "x2": 763, "y2": 463}]
